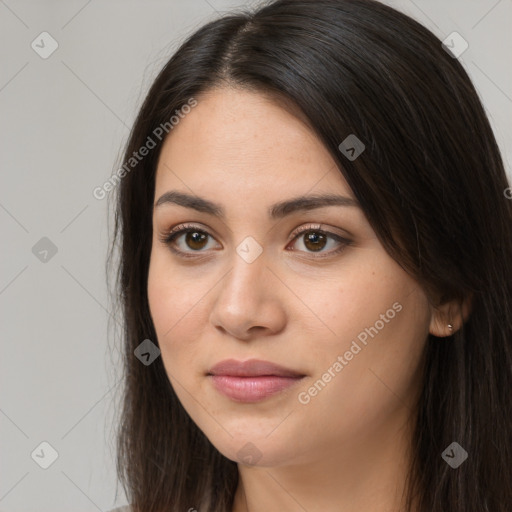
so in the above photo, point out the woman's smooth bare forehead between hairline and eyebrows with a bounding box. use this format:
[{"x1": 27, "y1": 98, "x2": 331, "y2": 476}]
[{"x1": 156, "y1": 88, "x2": 353, "y2": 199}]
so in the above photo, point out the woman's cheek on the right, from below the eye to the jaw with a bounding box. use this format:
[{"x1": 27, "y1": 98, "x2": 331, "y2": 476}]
[{"x1": 292, "y1": 259, "x2": 430, "y2": 416}]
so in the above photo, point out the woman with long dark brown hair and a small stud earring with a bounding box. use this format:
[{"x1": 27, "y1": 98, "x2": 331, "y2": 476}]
[{"x1": 107, "y1": 0, "x2": 512, "y2": 512}]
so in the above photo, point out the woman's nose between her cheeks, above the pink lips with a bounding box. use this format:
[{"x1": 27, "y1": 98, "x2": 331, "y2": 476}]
[{"x1": 210, "y1": 248, "x2": 286, "y2": 341}]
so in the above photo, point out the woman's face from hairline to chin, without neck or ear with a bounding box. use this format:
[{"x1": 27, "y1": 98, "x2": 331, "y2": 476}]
[{"x1": 148, "y1": 89, "x2": 431, "y2": 466}]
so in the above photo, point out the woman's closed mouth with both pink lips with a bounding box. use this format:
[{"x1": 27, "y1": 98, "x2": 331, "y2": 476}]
[{"x1": 207, "y1": 359, "x2": 306, "y2": 403}]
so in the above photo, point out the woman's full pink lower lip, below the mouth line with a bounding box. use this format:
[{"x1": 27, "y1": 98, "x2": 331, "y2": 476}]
[{"x1": 210, "y1": 375, "x2": 303, "y2": 402}]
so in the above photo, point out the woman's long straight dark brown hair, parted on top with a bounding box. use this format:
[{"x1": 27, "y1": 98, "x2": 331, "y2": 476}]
[{"x1": 108, "y1": 0, "x2": 512, "y2": 512}]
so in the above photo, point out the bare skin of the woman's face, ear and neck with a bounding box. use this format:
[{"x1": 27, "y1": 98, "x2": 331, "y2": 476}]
[{"x1": 148, "y1": 88, "x2": 462, "y2": 512}]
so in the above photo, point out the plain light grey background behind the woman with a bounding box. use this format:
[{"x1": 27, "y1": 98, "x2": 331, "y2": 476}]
[{"x1": 0, "y1": 0, "x2": 512, "y2": 512}]
